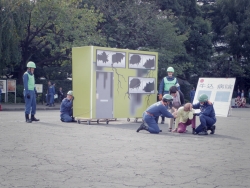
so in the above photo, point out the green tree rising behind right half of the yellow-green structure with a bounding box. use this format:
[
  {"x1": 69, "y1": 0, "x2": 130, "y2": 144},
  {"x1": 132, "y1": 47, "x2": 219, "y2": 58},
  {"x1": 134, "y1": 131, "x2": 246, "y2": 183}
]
[{"x1": 83, "y1": 0, "x2": 187, "y2": 78}]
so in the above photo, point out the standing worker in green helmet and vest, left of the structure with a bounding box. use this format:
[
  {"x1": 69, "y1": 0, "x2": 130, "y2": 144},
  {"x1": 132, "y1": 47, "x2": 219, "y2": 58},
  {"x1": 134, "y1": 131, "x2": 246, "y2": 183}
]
[{"x1": 23, "y1": 61, "x2": 39, "y2": 123}]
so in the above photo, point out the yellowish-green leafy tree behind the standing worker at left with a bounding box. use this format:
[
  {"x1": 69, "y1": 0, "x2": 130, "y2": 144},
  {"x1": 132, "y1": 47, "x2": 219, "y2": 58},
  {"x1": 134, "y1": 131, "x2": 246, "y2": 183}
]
[{"x1": 17, "y1": 0, "x2": 105, "y2": 81}]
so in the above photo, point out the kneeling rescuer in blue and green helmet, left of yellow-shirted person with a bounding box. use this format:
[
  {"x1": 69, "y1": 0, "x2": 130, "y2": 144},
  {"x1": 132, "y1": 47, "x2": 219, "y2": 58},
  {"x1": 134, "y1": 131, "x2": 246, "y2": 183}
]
[{"x1": 137, "y1": 94, "x2": 177, "y2": 134}]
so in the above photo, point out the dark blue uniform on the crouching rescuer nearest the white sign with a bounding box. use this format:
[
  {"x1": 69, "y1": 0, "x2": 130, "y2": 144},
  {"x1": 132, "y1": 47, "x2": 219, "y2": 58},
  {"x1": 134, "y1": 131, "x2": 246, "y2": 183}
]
[{"x1": 193, "y1": 102, "x2": 216, "y2": 133}]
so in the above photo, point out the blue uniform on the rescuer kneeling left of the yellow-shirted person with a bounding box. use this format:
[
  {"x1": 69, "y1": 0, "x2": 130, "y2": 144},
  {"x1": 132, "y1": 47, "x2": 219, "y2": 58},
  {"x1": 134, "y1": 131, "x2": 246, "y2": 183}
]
[{"x1": 143, "y1": 101, "x2": 174, "y2": 134}]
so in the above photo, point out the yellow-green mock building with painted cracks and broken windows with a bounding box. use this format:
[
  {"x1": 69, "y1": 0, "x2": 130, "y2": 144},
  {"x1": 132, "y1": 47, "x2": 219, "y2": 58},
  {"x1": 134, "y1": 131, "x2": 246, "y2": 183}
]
[{"x1": 72, "y1": 46, "x2": 158, "y2": 119}]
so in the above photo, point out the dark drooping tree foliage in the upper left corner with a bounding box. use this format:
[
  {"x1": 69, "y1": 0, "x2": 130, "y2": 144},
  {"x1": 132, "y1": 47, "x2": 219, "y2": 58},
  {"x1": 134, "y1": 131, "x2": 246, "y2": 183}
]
[{"x1": 0, "y1": 0, "x2": 29, "y2": 77}]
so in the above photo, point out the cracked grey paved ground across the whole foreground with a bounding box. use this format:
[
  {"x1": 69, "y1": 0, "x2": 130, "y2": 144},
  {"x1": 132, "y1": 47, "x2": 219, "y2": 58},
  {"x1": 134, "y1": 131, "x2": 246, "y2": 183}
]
[{"x1": 0, "y1": 108, "x2": 250, "y2": 188}]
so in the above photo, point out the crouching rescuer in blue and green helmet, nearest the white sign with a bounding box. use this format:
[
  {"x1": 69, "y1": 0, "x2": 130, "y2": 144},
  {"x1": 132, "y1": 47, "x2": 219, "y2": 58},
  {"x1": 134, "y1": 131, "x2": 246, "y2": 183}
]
[{"x1": 193, "y1": 94, "x2": 216, "y2": 135}]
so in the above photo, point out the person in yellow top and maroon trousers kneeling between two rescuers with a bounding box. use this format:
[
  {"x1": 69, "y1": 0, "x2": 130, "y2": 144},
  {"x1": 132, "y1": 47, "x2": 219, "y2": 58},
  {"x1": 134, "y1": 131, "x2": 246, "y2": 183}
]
[{"x1": 173, "y1": 103, "x2": 195, "y2": 133}]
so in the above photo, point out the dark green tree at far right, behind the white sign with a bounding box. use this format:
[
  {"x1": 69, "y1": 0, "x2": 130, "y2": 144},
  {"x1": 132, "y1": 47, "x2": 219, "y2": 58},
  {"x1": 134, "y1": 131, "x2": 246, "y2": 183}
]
[{"x1": 204, "y1": 0, "x2": 250, "y2": 88}]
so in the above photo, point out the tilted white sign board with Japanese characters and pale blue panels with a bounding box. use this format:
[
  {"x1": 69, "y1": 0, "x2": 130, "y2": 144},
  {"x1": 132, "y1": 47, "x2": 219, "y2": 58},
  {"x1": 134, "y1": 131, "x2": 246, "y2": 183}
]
[{"x1": 193, "y1": 78, "x2": 235, "y2": 117}]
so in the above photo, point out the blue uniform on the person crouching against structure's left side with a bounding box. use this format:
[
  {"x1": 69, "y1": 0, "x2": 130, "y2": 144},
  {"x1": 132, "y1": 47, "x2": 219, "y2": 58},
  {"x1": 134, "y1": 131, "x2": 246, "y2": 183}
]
[{"x1": 60, "y1": 98, "x2": 73, "y2": 122}]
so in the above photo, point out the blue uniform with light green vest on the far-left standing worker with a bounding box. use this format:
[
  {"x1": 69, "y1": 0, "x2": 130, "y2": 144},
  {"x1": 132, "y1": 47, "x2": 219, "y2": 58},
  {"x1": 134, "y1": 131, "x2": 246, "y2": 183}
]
[{"x1": 23, "y1": 71, "x2": 36, "y2": 115}]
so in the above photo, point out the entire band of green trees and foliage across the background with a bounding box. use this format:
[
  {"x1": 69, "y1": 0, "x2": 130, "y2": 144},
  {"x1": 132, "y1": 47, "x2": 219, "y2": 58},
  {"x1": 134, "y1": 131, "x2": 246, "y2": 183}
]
[{"x1": 0, "y1": 0, "x2": 250, "y2": 100}]
